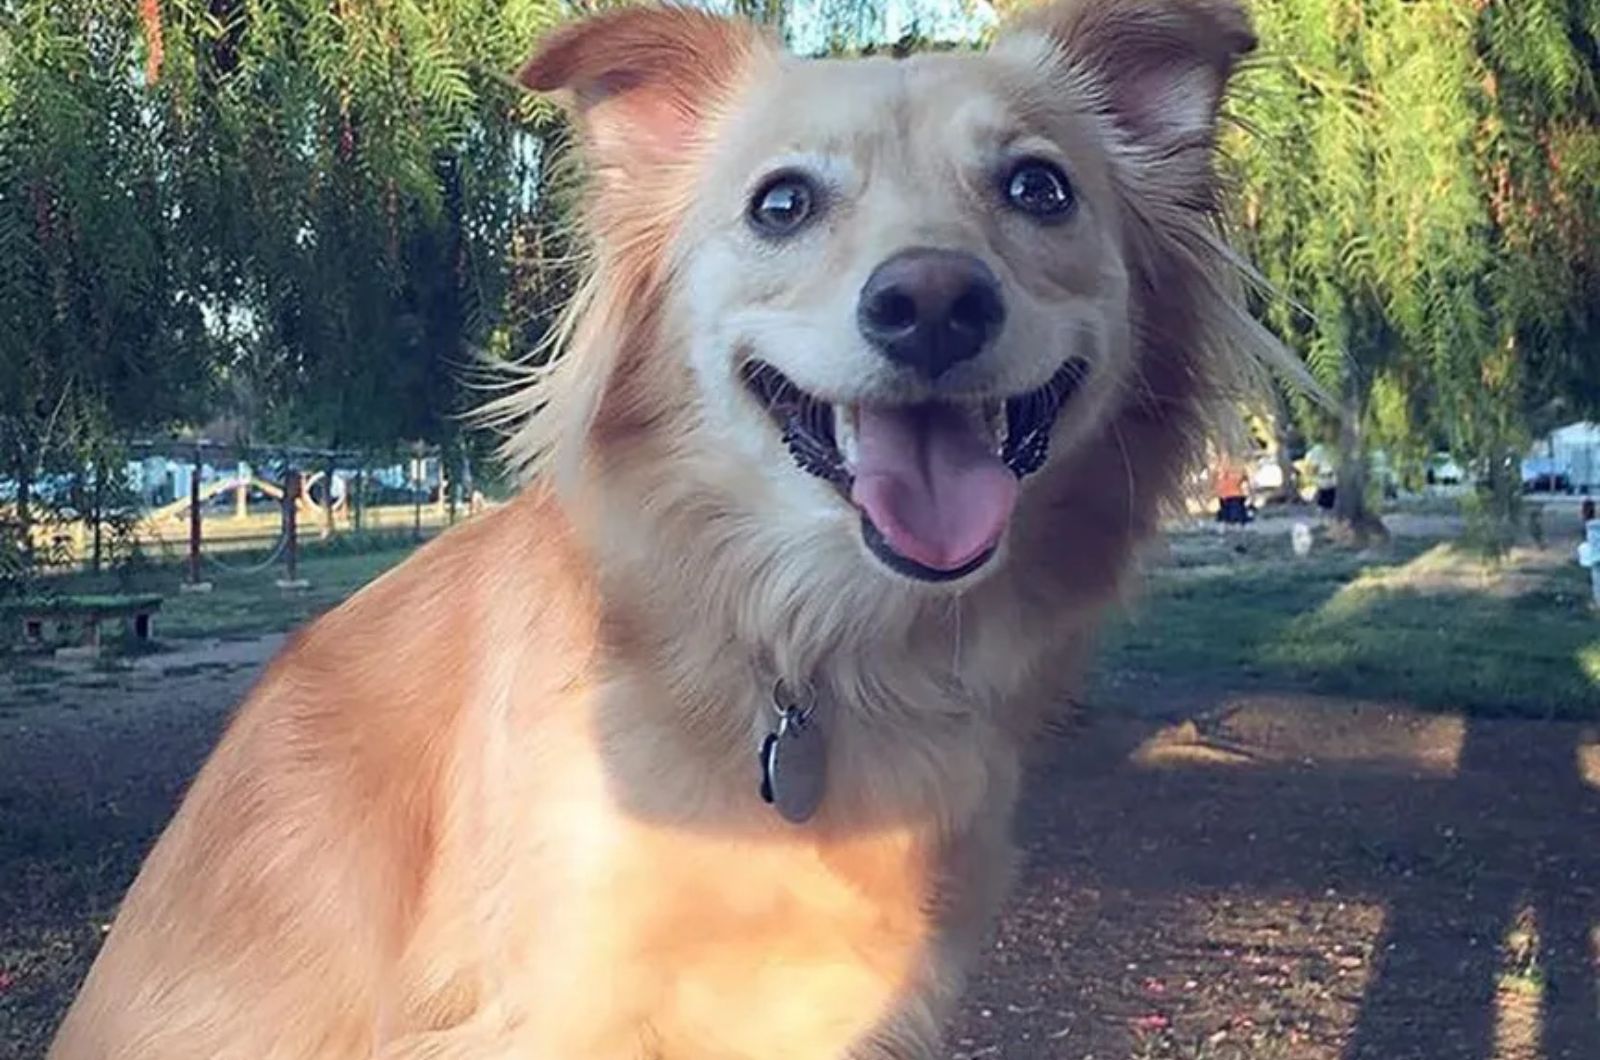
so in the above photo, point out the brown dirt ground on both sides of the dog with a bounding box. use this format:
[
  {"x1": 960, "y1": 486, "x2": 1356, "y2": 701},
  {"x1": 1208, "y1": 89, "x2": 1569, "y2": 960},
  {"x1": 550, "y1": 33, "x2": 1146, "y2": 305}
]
[{"x1": 0, "y1": 653, "x2": 1600, "y2": 1060}]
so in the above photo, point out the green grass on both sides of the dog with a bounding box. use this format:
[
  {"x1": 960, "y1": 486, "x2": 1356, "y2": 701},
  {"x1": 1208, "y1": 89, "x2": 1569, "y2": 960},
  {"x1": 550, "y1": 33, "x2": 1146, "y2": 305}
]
[{"x1": 11, "y1": 509, "x2": 1600, "y2": 719}]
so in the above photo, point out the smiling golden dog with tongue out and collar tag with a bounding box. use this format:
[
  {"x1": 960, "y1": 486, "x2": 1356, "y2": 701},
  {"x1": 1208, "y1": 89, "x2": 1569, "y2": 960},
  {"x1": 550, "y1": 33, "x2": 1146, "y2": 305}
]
[{"x1": 51, "y1": 0, "x2": 1288, "y2": 1060}]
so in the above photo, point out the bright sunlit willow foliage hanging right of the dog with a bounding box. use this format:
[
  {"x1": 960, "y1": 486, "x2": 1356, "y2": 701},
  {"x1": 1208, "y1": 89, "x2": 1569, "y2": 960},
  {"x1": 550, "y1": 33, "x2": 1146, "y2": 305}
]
[{"x1": 1226, "y1": 0, "x2": 1600, "y2": 532}]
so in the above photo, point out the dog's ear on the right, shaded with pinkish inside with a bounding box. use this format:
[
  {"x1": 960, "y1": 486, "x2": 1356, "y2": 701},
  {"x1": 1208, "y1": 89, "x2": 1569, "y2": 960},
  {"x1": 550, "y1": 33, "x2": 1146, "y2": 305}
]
[{"x1": 1008, "y1": 0, "x2": 1256, "y2": 152}]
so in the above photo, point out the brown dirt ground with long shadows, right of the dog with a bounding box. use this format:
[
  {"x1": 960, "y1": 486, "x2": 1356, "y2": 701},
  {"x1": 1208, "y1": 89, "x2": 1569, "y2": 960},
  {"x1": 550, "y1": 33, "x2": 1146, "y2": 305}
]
[{"x1": 954, "y1": 697, "x2": 1600, "y2": 1060}]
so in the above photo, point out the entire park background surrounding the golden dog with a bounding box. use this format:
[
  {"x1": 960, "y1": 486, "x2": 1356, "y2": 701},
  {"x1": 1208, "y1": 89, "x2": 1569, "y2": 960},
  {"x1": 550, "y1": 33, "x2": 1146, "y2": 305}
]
[{"x1": 0, "y1": 0, "x2": 1600, "y2": 1060}]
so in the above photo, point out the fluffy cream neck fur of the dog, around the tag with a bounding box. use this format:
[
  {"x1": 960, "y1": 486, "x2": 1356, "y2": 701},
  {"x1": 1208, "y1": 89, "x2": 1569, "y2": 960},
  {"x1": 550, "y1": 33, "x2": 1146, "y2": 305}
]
[{"x1": 553, "y1": 461, "x2": 1088, "y2": 833}]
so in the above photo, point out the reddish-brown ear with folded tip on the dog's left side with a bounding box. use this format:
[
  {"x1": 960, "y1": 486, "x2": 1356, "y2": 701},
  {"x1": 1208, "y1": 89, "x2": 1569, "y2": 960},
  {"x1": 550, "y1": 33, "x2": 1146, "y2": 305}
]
[{"x1": 520, "y1": 6, "x2": 771, "y2": 171}]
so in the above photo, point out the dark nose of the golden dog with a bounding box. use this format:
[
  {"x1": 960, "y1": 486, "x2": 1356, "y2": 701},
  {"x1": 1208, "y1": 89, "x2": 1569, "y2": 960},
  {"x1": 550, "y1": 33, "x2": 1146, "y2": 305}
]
[{"x1": 856, "y1": 247, "x2": 1005, "y2": 379}]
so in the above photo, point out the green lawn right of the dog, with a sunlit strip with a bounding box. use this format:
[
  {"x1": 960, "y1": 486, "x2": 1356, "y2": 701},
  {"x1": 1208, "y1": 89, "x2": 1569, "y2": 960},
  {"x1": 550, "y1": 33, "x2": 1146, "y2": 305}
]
[{"x1": 1101, "y1": 535, "x2": 1600, "y2": 719}]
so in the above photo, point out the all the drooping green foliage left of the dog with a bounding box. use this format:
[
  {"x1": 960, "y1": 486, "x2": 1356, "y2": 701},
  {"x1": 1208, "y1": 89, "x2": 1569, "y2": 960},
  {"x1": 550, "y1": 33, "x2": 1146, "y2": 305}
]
[{"x1": 0, "y1": 0, "x2": 565, "y2": 582}]
